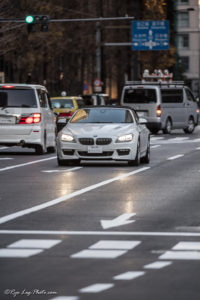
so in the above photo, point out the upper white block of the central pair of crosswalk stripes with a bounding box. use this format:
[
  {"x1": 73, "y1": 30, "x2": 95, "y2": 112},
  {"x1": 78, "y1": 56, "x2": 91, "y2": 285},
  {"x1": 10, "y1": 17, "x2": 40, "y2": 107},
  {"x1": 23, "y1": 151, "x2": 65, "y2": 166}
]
[{"x1": 89, "y1": 240, "x2": 141, "y2": 250}]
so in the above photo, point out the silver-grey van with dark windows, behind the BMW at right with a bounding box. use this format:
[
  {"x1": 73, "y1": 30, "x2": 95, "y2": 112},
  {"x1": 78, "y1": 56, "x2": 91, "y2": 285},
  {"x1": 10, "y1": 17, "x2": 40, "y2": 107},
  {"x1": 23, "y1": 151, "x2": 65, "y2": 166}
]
[{"x1": 121, "y1": 81, "x2": 199, "y2": 134}]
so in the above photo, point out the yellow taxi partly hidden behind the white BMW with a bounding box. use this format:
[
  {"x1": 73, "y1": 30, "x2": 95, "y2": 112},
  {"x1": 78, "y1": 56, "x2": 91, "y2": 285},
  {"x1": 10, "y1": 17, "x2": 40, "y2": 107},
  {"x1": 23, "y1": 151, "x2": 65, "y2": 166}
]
[{"x1": 51, "y1": 96, "x2": 84, "y2": 130}]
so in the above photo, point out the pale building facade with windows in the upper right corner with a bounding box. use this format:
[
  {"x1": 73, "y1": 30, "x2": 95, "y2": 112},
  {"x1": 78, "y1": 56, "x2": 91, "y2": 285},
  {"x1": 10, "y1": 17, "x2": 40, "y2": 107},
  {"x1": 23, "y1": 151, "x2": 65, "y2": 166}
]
[{"x1": 175, "y1": 0, "x2": 200, "y2": 96}]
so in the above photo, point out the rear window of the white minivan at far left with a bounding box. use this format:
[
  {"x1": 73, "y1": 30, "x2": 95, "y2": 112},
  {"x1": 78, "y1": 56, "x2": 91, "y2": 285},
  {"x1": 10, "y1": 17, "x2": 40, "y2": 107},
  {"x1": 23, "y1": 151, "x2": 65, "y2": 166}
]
[{"x1": 0, "y1": 89, "x2": 37, "y2": 107}]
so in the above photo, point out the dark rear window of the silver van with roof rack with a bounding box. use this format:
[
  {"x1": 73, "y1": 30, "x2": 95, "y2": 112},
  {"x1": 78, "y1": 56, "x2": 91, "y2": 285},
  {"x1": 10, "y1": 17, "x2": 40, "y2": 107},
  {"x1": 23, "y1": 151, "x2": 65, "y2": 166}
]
[{"x1": 124, "y1": 88, "x2": 157, "y2": 103}]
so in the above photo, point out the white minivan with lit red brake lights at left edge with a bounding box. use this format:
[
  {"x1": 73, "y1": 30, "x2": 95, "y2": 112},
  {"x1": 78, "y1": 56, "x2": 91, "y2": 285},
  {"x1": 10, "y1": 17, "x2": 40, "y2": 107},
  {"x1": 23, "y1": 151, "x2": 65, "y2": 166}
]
[{"x1": 0, "y1": 83, "x2": 56, "y2": 154}]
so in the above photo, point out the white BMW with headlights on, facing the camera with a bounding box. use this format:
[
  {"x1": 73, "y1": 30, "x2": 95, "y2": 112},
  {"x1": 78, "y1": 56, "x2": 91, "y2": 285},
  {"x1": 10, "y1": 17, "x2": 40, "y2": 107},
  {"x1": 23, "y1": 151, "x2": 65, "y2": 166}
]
[{"x1": 57, "y1": 106, "x2": 150, "y2": 166}]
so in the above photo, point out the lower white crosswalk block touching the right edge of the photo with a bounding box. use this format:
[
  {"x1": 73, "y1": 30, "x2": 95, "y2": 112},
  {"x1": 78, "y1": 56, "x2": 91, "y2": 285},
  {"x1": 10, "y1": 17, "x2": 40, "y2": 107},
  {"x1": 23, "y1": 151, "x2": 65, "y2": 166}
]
[{"x1": 159, "y1": 251, "x2": 200, "y2": 260}]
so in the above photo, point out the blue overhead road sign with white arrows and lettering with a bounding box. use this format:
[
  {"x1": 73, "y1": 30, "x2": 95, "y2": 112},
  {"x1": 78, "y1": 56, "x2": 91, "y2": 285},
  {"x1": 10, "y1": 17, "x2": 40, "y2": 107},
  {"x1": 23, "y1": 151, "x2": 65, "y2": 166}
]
[{"x1": 132, "y1": 20, "x2": 169, "y2": 50}]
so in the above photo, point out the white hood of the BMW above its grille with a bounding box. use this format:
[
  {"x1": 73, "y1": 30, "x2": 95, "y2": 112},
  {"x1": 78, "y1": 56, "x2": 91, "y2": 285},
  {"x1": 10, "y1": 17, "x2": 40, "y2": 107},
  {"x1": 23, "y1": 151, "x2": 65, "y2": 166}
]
[{"x1": 62, "y1": 123, "x2": 134, "y2": 137}]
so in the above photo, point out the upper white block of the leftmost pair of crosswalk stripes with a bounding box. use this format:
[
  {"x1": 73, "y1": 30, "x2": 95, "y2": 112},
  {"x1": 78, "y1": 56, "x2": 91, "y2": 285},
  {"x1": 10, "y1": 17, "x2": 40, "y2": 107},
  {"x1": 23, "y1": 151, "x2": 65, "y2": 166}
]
[{"x1": 8, "y1": 239, "x2": 61, "y2": 249}]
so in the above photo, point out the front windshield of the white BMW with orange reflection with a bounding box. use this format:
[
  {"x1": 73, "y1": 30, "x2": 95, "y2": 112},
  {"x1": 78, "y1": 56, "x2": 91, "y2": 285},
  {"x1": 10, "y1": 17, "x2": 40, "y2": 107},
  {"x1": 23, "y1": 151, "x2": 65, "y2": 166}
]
[{"x1": 70, "y1": 108, "x2": 133, "y2": 123}]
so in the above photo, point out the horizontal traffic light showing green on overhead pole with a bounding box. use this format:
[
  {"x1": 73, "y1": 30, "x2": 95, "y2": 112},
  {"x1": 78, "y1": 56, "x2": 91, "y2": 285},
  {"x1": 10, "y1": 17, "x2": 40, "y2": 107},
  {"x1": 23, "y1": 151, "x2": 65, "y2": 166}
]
[{"x1": 25, "y1": 15, "x2": 50, "y2": 33}]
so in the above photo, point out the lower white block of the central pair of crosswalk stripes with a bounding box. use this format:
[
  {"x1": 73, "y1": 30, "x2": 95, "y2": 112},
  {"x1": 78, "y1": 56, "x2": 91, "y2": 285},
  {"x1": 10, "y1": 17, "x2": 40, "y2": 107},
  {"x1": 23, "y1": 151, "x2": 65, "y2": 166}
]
[{"x1": 70, "y1": 250, "x2": 127, "y2": 259}]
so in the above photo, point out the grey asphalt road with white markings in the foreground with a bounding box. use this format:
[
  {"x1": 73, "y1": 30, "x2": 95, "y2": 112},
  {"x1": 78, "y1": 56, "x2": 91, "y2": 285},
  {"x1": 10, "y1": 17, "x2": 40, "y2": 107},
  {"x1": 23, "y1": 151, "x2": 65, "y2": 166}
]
[{"x1": 0, "y1": 127, "x2": 200, "y2": 300}]
